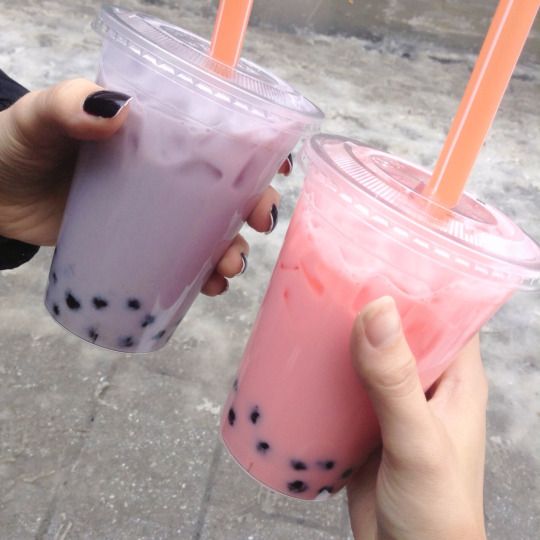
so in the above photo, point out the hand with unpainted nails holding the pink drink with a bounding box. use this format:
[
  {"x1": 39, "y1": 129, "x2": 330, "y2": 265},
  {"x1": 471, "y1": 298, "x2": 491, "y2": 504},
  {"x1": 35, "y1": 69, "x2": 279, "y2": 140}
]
[{"x1": 348, "y1": 297, "x2": 487, "y2": 540}]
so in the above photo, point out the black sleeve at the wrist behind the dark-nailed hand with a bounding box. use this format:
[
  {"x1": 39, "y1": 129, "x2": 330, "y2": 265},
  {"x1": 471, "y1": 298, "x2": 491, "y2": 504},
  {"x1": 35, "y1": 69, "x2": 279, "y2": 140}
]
[{"x1": 0, "y1": 69, "x2": 39, "y2": 270}]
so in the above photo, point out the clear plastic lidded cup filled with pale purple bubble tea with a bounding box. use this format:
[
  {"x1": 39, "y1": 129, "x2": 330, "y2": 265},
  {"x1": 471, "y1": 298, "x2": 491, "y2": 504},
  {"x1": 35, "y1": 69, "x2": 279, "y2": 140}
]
[{"x1": 46, "y1": 6, "x2": 322, "y2": 352}]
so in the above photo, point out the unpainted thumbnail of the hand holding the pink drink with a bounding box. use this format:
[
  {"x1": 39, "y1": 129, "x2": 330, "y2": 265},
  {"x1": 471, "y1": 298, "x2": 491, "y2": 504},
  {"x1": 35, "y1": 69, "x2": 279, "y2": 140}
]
[{"x1": 362, "y1": 296, "x2": 401, "y2": 349}]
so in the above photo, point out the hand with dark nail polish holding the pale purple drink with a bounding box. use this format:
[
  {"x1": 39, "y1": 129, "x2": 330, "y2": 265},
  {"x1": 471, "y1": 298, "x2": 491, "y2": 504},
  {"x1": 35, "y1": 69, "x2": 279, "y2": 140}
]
[{"x1": 0, "y1": 79, "x2": 292, "y2": 296}]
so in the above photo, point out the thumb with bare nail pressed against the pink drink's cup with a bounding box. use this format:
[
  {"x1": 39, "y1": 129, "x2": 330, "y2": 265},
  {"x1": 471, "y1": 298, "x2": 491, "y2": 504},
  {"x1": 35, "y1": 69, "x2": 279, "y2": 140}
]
[{"x1": 352, "y1": 296, "x2": 433, "y2": 460}]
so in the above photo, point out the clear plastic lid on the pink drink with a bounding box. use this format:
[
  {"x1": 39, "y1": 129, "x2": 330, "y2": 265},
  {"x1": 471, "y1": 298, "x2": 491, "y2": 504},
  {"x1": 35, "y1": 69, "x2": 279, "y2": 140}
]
[{"x1": 302, "y1": 134, "x2": 540, "y2": 289}]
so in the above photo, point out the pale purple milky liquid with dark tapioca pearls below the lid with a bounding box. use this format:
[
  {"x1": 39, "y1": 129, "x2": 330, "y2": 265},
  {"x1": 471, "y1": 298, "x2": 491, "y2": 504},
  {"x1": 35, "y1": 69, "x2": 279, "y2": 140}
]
[{"x1": 46, "y1": 43, "x2": 299, "y2": 352}]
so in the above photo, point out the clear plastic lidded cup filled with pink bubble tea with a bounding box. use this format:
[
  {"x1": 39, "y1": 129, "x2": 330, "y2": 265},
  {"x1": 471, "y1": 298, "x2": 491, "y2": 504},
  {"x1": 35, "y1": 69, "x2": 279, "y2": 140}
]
[{"x1": 221, "y1": 135, "x2": 540, "y2": 500}]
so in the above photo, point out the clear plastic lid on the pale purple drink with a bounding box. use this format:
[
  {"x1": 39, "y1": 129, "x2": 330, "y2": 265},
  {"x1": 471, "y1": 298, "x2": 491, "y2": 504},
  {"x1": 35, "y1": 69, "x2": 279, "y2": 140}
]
[{"x1": 94, "y1": 6, "x2": 323, "y2": 129}]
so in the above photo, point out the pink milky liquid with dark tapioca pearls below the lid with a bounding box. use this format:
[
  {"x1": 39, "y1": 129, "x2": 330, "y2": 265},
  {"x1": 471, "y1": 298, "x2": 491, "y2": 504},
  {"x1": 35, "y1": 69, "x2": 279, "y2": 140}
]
[{"x1": 222, "y1": 166, "x2": 511, "y2": 499}]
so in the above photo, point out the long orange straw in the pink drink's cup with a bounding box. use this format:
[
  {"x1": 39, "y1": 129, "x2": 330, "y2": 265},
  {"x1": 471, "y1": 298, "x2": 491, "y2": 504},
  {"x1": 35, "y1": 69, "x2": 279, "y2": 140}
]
[{"x1": 424, "y1": 0, "x2": 540, "y2": 208}]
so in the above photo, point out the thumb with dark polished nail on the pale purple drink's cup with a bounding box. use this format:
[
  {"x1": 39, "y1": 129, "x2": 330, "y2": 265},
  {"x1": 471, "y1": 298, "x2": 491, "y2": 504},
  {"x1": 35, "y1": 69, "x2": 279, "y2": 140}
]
[{"x1": 12, "y1": 79, "x2": 131, "y2": 146}]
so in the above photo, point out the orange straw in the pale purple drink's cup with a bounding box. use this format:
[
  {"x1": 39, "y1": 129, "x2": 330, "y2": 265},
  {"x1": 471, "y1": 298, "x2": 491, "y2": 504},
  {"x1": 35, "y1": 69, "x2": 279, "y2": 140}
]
[{"x1": 210, "y1": 0, "x2": 253, "y2": 68}]
